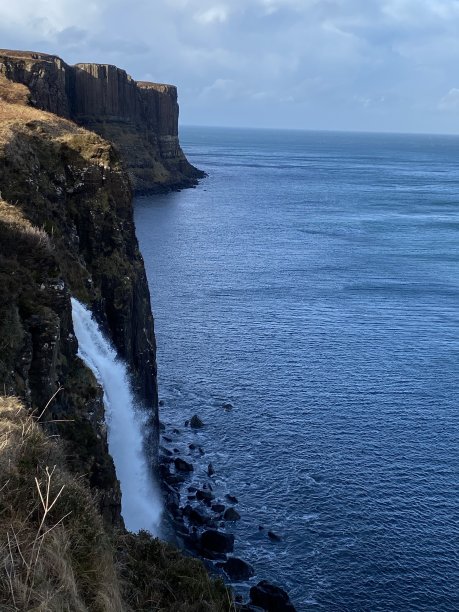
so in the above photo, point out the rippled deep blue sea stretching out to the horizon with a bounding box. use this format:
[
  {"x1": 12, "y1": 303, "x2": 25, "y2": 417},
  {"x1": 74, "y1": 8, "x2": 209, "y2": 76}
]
[{"x1": 136, "y1": 128, "x2": 459, "y2": 612}]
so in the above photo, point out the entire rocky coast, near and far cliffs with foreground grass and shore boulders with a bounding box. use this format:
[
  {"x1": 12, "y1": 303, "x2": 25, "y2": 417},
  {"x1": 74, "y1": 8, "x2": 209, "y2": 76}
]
[{"x1": 0, "y1": 51, "x2": 293, "y2": 612}]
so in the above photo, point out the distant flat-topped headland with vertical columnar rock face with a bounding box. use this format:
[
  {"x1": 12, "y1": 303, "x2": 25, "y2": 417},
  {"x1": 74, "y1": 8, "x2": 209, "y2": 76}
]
[{"x1": 0, "y1": 50, "x2": 203, "y2": 193}]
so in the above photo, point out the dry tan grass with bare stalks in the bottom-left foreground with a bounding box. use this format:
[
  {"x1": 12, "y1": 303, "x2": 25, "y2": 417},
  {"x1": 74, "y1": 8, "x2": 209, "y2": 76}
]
[{"x1": 0, "y1": 397, "x2": 125, "y2": 612}]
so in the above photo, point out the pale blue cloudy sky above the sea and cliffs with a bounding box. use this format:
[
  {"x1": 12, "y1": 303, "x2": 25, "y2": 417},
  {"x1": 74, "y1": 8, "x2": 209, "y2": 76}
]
[{"x1": 0, "y1": 0, "x2": 459, "y2": 134}]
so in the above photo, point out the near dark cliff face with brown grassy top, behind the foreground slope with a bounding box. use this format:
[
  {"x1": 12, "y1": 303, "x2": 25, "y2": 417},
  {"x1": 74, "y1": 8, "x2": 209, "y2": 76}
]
[{"x1": 0, "y1": 77, "x2": 158, "y2": 523}]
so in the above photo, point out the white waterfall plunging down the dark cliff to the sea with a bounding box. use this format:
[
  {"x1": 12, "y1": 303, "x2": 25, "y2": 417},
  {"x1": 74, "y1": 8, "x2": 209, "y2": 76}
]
[{"x1": 72, "y1": 298, "x2": 162, "y2": 535}]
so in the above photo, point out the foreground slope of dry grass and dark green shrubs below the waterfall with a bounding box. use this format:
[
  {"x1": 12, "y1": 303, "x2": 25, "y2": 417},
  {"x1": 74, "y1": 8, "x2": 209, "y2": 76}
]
[{"x1": 0, "y1": 397, "x2": 230, "y2": 612}]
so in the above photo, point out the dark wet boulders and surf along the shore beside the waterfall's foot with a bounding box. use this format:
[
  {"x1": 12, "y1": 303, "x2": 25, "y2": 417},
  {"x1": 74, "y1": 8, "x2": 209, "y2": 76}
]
[{"x1": 159, "y1": 412, "x2": 295, "y2": 612}]
